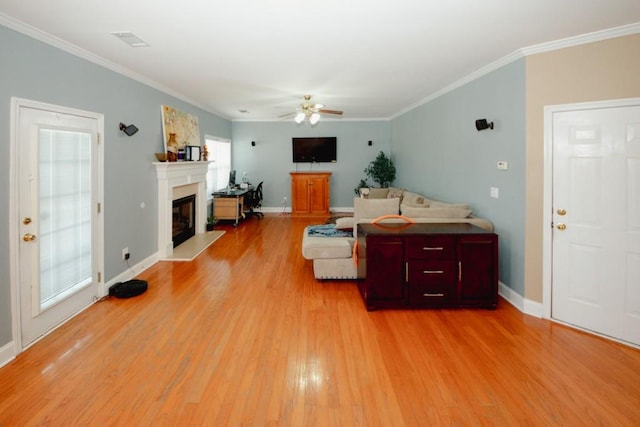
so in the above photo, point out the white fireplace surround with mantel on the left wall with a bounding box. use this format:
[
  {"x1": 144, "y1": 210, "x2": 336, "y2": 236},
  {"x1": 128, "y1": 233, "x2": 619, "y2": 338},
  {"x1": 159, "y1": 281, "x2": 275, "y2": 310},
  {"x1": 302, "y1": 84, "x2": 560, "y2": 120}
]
[{"x1": 153, "y1": 162, "x2": 210, "y2": 259}]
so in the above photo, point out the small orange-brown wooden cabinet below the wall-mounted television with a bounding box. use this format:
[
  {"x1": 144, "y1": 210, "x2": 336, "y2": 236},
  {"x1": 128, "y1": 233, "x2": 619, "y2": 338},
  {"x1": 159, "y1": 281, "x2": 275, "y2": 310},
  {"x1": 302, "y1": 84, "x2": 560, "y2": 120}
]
[{"x1": 291, "y1": 172, "x2": 331, "y2": 215}]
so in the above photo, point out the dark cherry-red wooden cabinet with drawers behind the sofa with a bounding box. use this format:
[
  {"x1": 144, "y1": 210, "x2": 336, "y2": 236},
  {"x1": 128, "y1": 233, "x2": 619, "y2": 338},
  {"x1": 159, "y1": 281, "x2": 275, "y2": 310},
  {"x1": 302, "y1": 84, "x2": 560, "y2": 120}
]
[{"x1": 358, "y1": 224, "x2": 498, "y2": 310}]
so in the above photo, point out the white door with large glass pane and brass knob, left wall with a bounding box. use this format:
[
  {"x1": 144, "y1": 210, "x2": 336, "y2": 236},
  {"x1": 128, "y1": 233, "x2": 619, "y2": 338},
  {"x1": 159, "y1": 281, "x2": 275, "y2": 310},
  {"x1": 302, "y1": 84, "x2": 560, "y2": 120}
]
[{"x1": 14, "y1": 100, "x2": 102, "y2": 348}]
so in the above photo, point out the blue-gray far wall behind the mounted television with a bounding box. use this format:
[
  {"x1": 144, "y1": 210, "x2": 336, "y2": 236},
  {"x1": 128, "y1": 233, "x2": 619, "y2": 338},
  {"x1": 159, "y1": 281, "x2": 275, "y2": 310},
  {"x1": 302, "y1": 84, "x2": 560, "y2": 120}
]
[{"x1": 231, "y1": 120, "x2": 390, "y2": 209}]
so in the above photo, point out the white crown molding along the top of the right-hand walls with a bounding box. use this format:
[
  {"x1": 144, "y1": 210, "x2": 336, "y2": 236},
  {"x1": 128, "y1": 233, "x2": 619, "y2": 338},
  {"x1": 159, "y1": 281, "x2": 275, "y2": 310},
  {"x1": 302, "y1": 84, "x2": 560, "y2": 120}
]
[{"x1": 389, "y1": 22, "x2": 640, "y2": 120}]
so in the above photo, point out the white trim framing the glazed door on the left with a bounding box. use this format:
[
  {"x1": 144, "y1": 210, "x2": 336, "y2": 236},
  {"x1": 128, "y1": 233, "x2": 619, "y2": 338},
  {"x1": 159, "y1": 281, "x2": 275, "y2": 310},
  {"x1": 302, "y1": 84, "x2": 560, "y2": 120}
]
[{"x1": 9, "y1": 97, "x2": 105, "y2": 356}]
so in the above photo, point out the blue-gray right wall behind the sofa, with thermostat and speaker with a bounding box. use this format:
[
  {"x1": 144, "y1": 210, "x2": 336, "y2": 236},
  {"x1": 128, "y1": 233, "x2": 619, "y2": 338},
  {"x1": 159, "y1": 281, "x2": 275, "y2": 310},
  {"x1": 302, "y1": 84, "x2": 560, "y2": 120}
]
[{"x1": 391, "y1": 59, "x2": 526, "y2": 295}]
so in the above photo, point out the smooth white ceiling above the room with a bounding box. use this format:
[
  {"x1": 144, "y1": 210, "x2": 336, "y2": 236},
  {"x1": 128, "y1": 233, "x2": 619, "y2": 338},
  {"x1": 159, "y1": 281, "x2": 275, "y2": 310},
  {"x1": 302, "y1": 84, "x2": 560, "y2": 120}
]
[{"x1": 0, "y1": 0, "x2": 640, "y2": 120}]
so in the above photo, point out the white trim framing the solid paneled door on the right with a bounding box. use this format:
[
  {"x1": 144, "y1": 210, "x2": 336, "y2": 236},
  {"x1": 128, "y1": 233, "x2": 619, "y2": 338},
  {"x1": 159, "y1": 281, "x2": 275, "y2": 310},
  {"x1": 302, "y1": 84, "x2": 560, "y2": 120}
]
[{"x1": 542, "y1": 98, "x2": 640, "y2": 320}]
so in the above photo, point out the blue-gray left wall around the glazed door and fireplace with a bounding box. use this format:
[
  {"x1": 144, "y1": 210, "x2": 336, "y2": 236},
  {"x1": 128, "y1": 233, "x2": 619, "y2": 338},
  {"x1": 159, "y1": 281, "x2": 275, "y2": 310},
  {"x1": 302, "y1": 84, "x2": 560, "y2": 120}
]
[{"x1": 0, "y1": 26, "x2": 231, "y2": 347}]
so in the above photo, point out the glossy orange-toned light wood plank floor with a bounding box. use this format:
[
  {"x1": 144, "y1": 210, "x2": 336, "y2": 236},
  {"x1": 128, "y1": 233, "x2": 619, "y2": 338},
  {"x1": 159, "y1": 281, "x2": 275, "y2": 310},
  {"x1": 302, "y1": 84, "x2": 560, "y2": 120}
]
[{"x1": 0, "y1": 214, "x2": 640, "y2": 426}]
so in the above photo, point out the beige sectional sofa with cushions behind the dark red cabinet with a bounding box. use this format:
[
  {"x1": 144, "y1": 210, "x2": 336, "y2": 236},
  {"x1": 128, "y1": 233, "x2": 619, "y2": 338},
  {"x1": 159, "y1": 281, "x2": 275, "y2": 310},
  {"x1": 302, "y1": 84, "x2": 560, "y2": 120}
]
[{"x1": 302, "y1": 188, "x2": 493, "y2": 280}]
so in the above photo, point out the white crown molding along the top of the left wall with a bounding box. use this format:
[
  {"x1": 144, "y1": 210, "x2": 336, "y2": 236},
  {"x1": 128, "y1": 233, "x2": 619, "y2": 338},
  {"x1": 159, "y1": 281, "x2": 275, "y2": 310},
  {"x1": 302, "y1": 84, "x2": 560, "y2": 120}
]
[{"x1": 0, "y1": 12, "x2": 231, "y2": 120}]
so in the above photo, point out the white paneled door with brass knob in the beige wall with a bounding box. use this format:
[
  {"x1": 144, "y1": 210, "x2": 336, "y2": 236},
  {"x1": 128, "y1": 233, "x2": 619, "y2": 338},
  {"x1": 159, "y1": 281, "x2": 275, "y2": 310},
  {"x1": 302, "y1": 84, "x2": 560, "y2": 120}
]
[{"x1": 551, "y1": 105, "x2": 640, "y2": 345}]
